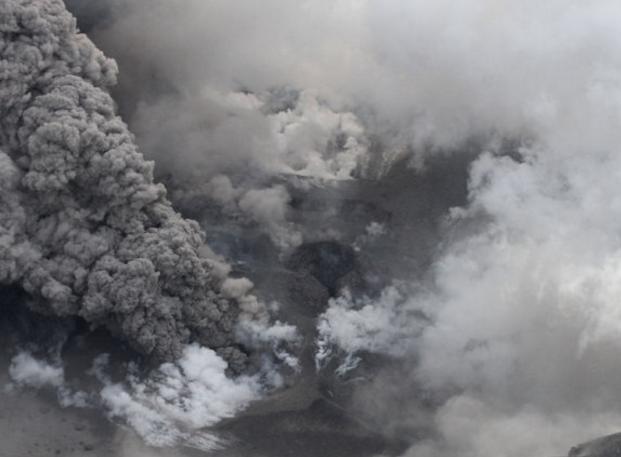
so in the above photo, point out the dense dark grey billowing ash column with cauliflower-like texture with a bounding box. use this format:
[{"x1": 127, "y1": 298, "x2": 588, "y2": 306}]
[{"x1": 0, "y1": 0, "x2": 236, "y2": 358}]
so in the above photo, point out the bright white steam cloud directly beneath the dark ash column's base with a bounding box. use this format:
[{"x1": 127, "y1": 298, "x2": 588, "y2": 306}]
[{"x1": 98, "y1": 345, "x2": 263, "y2": 450}]
